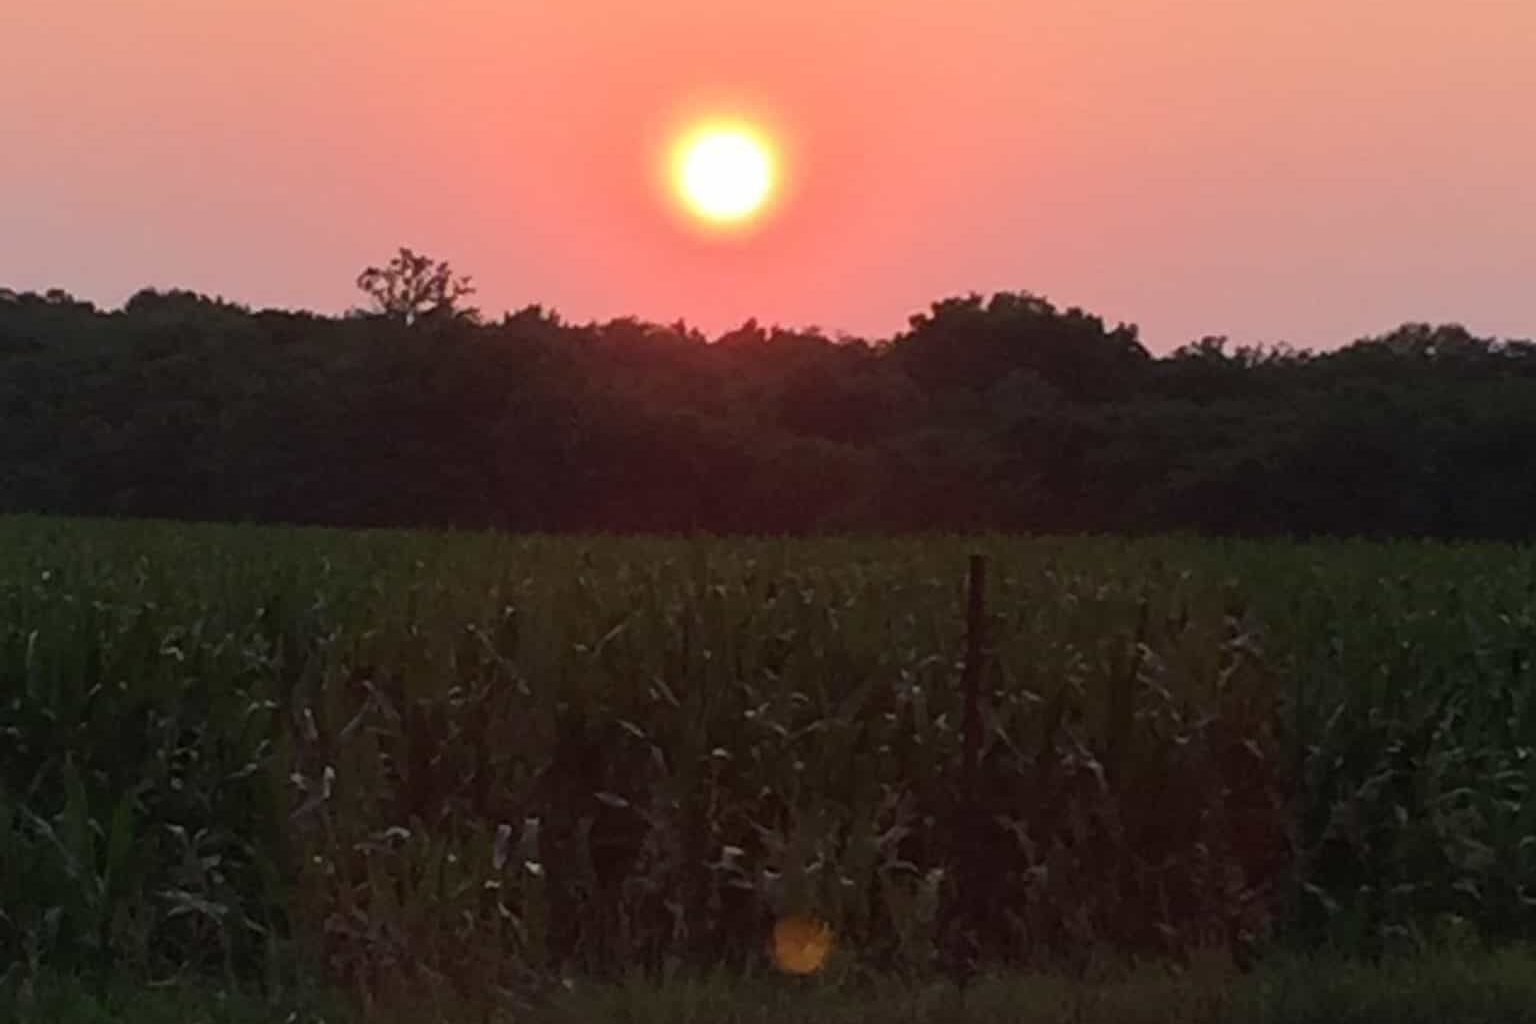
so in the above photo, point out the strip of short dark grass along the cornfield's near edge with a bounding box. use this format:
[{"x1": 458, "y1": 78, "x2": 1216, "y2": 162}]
[{"x1": 12, "y1": 947, "x2": 1536, "y2": 1024}]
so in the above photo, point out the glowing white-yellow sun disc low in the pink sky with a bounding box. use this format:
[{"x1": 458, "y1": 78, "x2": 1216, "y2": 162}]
[{"x1": 671, "y1": 123, "x2": 779, "y2": 227}]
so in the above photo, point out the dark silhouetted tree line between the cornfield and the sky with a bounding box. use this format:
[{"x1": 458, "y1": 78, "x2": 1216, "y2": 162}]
[{"x1": 0, "y1": 250, "x2": 1536, "y2": 539}]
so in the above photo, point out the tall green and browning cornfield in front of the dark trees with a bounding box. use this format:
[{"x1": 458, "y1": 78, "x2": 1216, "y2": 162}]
[{"x1": 0, "y1": 517, "x2": 1536, "y2": 1001}]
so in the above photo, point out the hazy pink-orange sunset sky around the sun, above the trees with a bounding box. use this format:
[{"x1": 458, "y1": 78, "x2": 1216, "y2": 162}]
[{"x1": 0, "y1": 0, "x2": 1536, "y2": 352}]
